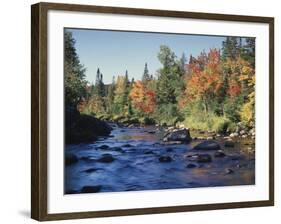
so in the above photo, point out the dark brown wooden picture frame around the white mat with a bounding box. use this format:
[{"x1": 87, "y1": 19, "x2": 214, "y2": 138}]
[{"x1": 31, "y1": 3, "x2": 274, "y2": 221}]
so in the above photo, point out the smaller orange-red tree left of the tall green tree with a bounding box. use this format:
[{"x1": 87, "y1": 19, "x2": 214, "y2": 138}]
[{"x1": 129, "y1": 81, "x2": 156, "y2": 114}]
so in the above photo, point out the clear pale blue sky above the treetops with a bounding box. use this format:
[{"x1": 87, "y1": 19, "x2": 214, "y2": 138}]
[{"x1": 67, "y1": 29, "x2": 225, "y2": 84}]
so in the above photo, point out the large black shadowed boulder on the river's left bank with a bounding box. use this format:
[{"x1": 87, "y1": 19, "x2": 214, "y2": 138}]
[{"x1": 65, "y1": 107, "x2": 112, "y2": 144}]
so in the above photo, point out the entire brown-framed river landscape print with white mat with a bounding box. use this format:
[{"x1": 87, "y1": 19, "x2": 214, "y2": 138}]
[{"x1": 31, "y1": 3, "x2": 274, "y2": 221}]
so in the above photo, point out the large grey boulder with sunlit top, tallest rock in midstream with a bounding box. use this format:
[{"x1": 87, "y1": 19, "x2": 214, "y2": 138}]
[{"x1": 163, "y1": 128, "x2": 192, "y2": 143}]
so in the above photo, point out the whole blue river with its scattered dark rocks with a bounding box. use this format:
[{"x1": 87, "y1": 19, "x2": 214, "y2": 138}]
[{"x1": 65, "y1": 124, "x2": 255, "y2": 194}]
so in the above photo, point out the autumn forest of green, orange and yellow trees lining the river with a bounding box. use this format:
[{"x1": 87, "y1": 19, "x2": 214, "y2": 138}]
[{"x1": 64, "y1": 31, "x2": 255, "y2": 134}]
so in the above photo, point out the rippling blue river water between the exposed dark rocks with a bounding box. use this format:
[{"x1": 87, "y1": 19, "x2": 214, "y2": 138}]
[{"x1": 65, "y1": 127, "x2": 255, "y2": 193}]
